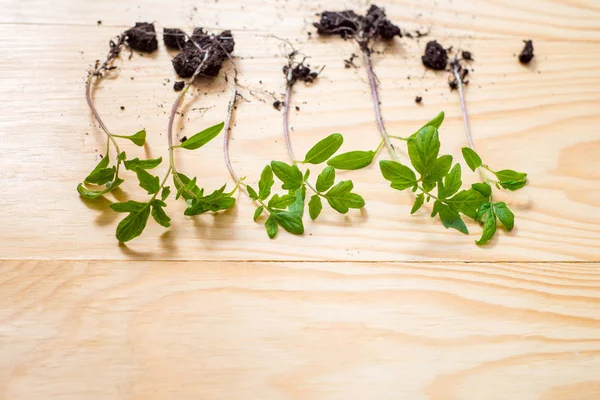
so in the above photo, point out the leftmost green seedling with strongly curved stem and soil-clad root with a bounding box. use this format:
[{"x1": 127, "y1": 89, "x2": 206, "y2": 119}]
[{"x1": 77, "y1": 22, "x2": 158, "y2": 199}]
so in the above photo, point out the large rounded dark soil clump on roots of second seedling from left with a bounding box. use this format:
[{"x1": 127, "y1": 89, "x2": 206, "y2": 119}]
[{"x1": 173, "y1": 28, "x2": 235, "y2": 78}]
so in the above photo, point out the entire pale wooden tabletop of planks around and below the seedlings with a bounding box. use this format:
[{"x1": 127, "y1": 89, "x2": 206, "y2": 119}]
[{"x1": 0, "y1": 0, "x2": 600, "y2": 400}]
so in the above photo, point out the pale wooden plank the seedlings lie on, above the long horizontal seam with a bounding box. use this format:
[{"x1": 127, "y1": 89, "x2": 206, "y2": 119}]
[{"x1": 0, "y1": 3, "x2": 600, "y2": 261}]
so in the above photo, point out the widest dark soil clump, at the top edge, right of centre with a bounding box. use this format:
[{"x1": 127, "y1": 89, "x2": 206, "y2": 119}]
[{"x1": 313, "y1": 4, "x2": 402, "y2": 53}]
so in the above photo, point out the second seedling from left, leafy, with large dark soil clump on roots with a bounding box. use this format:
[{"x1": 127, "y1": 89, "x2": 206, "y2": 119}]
[{"x1": 106, "y1": 31, "x2": 237, "y2": 242}]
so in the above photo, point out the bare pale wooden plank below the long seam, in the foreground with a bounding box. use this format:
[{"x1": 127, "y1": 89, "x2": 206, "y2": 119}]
[{"x1": 0, "y1": 261, "x2": 600, "y2": 400}]
